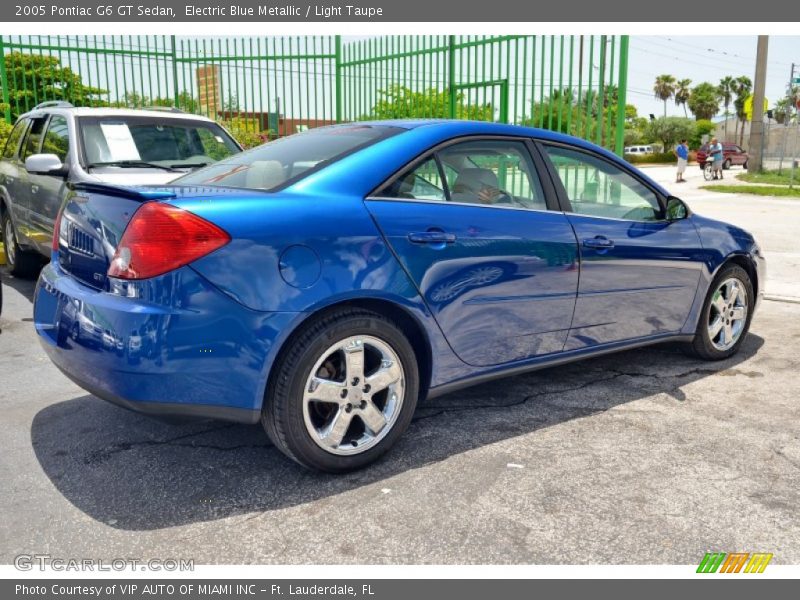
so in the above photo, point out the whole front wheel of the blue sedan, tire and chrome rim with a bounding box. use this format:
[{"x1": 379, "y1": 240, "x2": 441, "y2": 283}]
[{"x1": 691, "y1": 264, "x2": 755, "y2": 360}]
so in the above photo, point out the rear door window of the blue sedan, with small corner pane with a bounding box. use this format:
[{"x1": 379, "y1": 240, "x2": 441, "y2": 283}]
[{"x1": 378, "y1": 140, "x2": 547, "y2": 210}]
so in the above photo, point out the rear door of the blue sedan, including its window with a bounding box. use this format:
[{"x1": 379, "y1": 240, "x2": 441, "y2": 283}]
[{"x1": 366, "y1": 138, "x2": 578, "y2": 366}]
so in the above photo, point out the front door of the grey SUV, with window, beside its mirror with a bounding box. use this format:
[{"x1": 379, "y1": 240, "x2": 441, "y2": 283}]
[{"x1": 28, "y1": 115, "x2": 69, "y2": 254}]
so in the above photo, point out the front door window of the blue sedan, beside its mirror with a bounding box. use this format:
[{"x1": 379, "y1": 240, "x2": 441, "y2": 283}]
[{"x1": 545, "y1": 146, "x2": 662, "y2": 221}]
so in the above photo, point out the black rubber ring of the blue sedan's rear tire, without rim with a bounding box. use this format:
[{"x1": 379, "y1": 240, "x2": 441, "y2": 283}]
[{"x1": 271, "y1": 315, "x2": 419, "y2": 472}]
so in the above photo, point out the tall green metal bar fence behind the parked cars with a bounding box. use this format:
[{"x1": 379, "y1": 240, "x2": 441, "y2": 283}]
[{"x1": 0, "y1": 35, "x2": 628, "y2": 153}]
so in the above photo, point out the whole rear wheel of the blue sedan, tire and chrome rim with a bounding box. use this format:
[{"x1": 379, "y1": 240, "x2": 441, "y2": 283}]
[{"x1": 261, "y1": 308, "x2": 419, "y2": 473}]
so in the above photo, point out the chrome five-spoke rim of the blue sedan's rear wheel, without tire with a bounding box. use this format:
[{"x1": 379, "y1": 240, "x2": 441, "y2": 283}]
[{"x1": 303, "y1": 335, "x2": 405, "y2": 455}]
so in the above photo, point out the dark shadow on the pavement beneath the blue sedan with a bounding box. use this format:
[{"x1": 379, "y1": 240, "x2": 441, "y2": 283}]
[{"x1": 31, "y1": 334, "x2": 764, "y2": 530}]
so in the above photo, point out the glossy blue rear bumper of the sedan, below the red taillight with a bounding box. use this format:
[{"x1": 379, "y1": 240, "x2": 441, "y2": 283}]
[{"x1": 34, "y1": 262, "x2": 298, "y2": 423}]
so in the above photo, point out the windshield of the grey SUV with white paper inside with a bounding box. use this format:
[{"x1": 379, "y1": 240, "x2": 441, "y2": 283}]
[{"x1": 78, "y1": 115, "x2": 240, "y2": 169}]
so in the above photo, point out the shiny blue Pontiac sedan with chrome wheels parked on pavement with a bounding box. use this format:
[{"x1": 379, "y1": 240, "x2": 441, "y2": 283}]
[{"x1": 34, "y1": 121, "x2": 765, "y2": 472}]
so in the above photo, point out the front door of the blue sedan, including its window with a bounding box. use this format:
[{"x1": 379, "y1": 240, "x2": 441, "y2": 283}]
[{"x1": 542, "y1": 144, "x2": 703, "y2": 350}]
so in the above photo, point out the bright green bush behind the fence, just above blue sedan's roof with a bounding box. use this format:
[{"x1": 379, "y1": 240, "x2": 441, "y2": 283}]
[{"x1": 364, "y1": 84, "x2": 495, "y2": 121}]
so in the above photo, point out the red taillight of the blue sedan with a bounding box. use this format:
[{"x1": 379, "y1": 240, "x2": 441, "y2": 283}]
[{"x1": 108, "y1": 202, "x2": 231, "y2": 279}]
